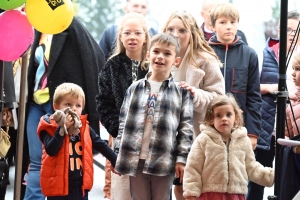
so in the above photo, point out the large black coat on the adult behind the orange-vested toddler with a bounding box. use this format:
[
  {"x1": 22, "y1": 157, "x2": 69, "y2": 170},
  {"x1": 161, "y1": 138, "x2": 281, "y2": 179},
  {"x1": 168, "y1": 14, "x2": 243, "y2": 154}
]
[{"x1": 27, "y1": 17, "x2": 105, "y2": 134}]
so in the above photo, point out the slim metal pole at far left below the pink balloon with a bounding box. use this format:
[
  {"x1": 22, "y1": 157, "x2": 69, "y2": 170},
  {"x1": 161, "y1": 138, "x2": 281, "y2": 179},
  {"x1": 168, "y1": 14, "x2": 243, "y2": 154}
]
[{"x1": 14, "y1": 53, "x2": 28, "y2": 200}]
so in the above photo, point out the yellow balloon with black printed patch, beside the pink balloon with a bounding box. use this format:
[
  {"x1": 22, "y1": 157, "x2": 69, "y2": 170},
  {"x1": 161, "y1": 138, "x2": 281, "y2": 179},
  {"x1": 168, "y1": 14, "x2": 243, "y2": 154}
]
[{"x1": 25, "y1": 0, "x2": 74, "y2": 34}]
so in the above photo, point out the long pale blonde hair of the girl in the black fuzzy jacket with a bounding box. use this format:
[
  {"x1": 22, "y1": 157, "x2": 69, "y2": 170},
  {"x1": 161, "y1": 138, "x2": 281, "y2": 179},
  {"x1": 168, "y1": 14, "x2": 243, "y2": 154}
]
[{"x1": 108, "y1": 13, "x2": 151, "y2": 70}]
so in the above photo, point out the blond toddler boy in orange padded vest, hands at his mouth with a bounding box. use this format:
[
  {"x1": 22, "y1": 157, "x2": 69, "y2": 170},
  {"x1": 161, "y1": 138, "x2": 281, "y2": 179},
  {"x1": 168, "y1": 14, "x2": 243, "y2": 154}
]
[{"x1": 37, "y1": 83, "x2": 117, "y2": 200}]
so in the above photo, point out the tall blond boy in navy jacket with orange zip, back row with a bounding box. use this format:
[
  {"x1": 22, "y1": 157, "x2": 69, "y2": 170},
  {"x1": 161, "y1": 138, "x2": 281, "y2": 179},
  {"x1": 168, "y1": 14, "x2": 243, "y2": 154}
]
[{"x1": 209, "y1": 3, "x2": 262, "y2": 150}]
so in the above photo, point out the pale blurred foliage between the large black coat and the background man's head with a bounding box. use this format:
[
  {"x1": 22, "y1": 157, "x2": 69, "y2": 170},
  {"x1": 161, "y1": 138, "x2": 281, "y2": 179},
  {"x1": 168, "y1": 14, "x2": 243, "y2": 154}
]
[{"x1": 76, "y1": 0, "x2": 123, "y2": 41}]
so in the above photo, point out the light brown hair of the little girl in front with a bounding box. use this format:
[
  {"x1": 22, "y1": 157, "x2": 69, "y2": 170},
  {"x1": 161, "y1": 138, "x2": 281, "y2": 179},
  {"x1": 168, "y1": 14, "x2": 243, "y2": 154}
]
[{"x1": 203, "y1": 93, "x2": 244, "y2": 129}]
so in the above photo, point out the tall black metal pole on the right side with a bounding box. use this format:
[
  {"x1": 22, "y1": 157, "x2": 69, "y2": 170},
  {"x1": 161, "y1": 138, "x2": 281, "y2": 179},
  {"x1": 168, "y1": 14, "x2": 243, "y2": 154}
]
[{"x1": 268, "y1": 0, "x2": 288, "y2": 200}]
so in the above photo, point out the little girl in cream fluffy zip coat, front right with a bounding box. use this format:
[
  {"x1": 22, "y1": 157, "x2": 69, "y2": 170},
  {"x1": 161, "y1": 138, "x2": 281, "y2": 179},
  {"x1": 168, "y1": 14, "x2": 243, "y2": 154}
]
[{"x1": 183, "y1": 94, "x2": 274, "y2": 200}]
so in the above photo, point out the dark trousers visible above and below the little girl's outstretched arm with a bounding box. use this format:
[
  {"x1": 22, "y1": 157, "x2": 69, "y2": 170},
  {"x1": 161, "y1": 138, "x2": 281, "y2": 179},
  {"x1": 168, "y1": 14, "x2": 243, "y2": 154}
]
[{"x1": 246, "y1": 136, "x2": 275, "y2": 200}]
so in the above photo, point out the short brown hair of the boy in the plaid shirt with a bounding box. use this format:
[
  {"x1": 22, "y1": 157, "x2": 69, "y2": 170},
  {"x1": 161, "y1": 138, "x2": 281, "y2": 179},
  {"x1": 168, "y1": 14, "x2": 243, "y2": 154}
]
[{"x1": 149, "y1": 33, "x2": 181, "y2": 56}]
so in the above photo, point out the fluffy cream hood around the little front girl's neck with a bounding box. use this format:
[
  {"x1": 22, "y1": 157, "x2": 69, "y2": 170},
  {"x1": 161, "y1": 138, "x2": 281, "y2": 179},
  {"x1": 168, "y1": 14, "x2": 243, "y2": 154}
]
[{"x1": 200, "y1": 124, "x2": 247, "y2": 139}]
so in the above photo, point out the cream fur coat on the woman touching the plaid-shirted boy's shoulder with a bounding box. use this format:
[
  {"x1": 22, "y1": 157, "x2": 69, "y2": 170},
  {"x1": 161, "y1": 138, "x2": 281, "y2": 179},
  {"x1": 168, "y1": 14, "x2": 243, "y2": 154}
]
[{"x1": 176, "y1": 50, "x2": 225, "y2": 137}]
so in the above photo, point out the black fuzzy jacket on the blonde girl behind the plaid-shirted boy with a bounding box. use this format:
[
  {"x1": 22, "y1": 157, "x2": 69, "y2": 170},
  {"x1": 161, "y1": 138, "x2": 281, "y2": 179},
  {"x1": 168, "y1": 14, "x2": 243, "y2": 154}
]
[{"x1": 96, "y1": 53, "x2": 148, "y2": 137}]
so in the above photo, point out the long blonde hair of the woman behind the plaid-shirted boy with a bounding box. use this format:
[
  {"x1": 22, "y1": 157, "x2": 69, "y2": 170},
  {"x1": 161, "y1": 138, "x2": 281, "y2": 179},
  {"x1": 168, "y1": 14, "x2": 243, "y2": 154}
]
[{"x1": 163, "y1": 11, "x2": 221, "y2": 67}]
